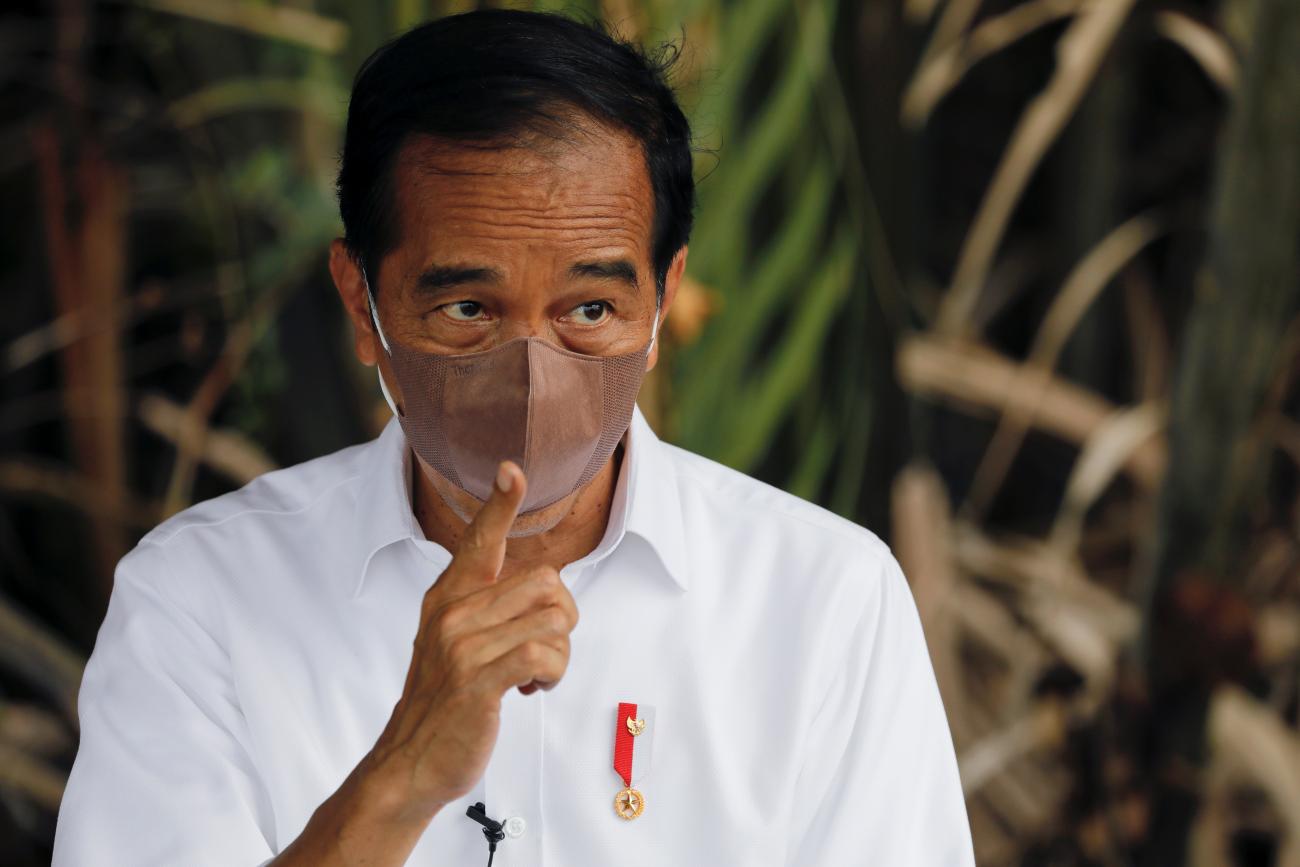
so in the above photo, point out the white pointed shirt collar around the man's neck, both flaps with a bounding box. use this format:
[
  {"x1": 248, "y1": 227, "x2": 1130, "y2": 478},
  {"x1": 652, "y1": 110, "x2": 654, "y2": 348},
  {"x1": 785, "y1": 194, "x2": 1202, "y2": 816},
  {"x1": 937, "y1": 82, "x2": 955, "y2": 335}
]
[{"x1": 350, "y1": 407, "x2": 689, "y2": 598}]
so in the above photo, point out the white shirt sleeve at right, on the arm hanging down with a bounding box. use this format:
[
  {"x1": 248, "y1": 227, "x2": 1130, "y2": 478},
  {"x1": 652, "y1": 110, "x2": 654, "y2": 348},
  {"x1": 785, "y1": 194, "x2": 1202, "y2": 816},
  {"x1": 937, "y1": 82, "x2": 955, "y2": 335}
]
[{"x1": 787, "y1": 554, "x2": 975, "y2": 867}]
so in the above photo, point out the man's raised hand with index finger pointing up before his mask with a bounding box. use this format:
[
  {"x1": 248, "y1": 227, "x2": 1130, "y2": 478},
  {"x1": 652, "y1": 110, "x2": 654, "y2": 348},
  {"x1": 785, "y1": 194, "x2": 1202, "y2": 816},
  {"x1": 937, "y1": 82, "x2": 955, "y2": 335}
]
[{"x1": 358, "y1": 461, "x2": 577, "y2": 819}]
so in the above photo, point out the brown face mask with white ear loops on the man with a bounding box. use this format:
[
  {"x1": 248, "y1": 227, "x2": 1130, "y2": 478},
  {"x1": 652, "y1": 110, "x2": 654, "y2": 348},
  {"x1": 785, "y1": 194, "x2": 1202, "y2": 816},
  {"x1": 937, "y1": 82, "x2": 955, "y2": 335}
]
[{"x1": 363, "y1": 274, "x2": 659, "y2": 515}]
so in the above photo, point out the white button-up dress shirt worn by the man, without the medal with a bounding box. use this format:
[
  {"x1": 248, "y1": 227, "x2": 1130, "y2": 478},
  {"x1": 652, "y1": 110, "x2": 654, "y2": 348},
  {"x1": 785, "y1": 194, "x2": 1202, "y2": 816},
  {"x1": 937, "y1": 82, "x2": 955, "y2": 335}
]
[{"x1": 53, "y1": 409, "x2": 974, "y2": 867}]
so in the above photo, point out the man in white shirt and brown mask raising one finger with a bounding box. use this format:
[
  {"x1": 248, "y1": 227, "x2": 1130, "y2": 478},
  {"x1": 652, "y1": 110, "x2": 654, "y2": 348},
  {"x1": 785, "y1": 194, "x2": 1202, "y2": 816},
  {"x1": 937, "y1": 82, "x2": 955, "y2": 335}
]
[{"x1": 55, "y1": 10, "x2": 972, "y2": 867}]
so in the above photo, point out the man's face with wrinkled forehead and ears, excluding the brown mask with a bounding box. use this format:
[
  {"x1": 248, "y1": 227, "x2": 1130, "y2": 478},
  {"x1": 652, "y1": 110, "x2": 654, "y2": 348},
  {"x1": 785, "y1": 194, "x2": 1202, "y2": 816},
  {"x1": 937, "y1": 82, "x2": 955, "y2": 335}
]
[{"x1": 333, "y1": 119, "x2": 684, "y2": 536}]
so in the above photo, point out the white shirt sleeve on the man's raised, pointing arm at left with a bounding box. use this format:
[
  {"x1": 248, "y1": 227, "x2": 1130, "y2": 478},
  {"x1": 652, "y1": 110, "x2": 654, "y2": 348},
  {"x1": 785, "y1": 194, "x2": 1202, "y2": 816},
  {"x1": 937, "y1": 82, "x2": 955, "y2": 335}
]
[{"x1": 53, "y1": 542, "x2": 274, "y2": 867}]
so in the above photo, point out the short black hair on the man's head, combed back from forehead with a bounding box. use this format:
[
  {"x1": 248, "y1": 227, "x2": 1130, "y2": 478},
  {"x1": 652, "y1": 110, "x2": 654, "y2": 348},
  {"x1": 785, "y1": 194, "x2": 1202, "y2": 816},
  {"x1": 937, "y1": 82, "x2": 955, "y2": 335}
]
[{"x1": 338, "y1": 9, "x2": 696, "y2": 299}]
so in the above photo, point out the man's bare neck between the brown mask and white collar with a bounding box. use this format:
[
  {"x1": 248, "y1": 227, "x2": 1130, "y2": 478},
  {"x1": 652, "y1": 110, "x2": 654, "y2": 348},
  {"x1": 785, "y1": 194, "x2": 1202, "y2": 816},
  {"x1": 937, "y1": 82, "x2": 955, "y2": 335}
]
[{"x1": 411, "y1": 442, "x2": 623, "y2": 577}]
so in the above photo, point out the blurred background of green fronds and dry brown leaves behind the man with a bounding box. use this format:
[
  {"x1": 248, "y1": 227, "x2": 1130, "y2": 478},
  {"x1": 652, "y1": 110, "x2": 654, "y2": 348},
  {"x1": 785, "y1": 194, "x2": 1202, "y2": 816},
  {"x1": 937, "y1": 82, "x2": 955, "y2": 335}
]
[{"x1": 0, "y1": 0, "x2": 1300, "y2": 867}]
